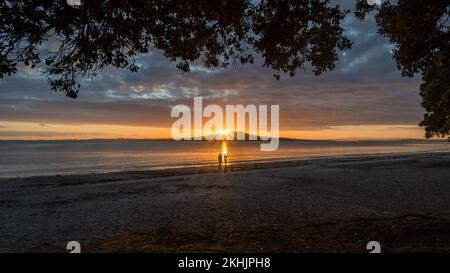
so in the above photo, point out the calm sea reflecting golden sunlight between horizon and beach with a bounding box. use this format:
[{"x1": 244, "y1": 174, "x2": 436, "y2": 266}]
[{"x1": 0, "y1": 141, "x2": 450, "y2": 177}]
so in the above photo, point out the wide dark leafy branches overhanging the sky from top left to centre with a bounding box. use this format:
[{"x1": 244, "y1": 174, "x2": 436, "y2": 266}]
[{"x1": 0, "y1": 0, "x2": 350, "y2": 98}]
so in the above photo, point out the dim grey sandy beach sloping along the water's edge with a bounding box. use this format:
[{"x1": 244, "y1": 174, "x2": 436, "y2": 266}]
[{"x1": 0, "y1": 153, "x2": 450, "y2": 252}]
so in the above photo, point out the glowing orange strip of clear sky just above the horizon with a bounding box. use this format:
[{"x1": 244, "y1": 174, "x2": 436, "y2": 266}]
[{"x1": 0, "y1": 122, "x2": 424, "y2": 140}]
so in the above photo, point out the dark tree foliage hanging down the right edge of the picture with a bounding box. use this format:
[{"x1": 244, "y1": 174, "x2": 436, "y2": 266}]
[{"x1": 355, "y1": 0, "x2": 450, "y2": 138}]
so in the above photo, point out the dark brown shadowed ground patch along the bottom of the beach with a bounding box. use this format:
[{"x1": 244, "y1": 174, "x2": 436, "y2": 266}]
[{"x1": 85, "y1": 215, "x2": 450, "y2": 252}]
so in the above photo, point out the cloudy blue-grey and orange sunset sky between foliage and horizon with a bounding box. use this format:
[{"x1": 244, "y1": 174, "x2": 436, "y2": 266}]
[{"x1": 0, "y1": 2, "x2": 424, "y2": 139}]
